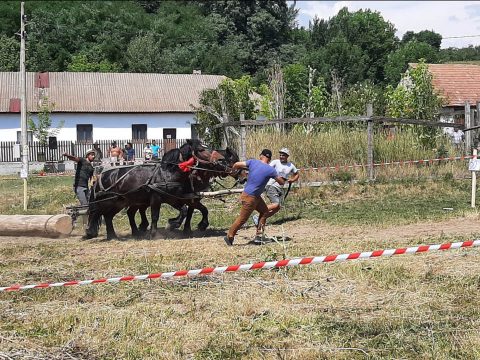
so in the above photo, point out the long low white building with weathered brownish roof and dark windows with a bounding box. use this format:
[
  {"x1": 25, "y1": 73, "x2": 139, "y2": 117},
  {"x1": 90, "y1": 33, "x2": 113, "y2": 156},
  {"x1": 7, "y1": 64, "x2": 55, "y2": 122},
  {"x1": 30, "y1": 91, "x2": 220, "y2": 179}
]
[{"x1": 0, "y1": 72, "x2": 225, "y2": 143}]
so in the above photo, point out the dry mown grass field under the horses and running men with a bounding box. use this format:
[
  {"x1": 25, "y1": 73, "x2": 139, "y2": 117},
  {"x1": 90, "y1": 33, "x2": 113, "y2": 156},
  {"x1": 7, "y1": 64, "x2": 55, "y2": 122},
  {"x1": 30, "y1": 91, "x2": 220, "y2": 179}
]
[{"x1": 0, "y1": 173, "x2": 480, "y2": 359}]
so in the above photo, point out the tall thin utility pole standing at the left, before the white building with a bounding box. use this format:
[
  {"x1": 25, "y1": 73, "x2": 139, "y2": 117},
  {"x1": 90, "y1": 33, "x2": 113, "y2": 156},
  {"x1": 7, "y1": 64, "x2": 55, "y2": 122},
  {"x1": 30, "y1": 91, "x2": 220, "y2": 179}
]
[{"x1": 20, "y1": 1, "x2": 28, "y2": 210}]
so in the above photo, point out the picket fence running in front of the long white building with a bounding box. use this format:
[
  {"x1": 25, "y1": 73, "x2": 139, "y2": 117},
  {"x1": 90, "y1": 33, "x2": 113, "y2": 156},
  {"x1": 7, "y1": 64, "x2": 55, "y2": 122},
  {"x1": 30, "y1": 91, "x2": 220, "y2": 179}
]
[{"x1": 0, "y1": 139, "x2": 190, "y2": 162}]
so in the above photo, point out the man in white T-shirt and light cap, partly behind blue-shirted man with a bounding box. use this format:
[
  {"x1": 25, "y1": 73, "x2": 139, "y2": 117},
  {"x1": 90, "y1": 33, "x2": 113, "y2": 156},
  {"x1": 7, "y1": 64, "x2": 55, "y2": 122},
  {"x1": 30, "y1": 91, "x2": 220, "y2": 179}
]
[{"x1": 253, "y1": 148, "x2": 300, "y2": 226}]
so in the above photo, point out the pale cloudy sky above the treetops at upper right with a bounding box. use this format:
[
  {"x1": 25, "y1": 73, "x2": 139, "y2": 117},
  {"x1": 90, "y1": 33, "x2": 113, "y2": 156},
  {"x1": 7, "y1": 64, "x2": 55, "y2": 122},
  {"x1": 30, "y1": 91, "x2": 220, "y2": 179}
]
[{"x1": 288, "y1": 1, "x2": 480, "y2": 48}]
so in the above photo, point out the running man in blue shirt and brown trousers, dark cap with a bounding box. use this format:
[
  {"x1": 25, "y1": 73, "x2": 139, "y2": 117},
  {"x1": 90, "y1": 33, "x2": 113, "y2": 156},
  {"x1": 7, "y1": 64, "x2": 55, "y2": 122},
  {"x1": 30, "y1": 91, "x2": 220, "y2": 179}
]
[{"x1": 223, "y1": 149, "x2": 285, "y2": 246}]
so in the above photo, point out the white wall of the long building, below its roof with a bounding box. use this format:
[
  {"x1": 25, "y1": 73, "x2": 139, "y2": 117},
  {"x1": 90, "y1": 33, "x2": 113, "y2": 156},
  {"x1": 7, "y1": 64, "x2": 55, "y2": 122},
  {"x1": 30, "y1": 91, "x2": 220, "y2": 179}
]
[{"x1": 0, "y1": 113, "x2": 195, "y2": 141}]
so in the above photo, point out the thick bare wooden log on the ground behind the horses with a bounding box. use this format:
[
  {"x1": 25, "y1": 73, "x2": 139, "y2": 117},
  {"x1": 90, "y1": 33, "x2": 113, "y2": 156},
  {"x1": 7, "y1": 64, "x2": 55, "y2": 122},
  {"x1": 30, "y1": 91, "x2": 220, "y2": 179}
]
[{"x1": 0, "y1": 214, "x2": 73, "y2": 238}]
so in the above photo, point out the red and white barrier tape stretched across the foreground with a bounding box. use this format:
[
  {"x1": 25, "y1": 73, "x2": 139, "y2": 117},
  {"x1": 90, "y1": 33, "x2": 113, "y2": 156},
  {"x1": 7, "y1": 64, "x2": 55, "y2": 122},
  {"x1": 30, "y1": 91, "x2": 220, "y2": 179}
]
[{"x1": 0, "y1": 240, "x2": 480, "y2": 292}]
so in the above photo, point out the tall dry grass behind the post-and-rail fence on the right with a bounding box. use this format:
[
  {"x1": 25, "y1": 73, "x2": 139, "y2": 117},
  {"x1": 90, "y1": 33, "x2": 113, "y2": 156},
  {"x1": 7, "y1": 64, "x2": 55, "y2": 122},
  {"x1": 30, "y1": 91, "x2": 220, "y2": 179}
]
[{"x1": 247, "y1": 126, "x2": 455, "y2": 166}]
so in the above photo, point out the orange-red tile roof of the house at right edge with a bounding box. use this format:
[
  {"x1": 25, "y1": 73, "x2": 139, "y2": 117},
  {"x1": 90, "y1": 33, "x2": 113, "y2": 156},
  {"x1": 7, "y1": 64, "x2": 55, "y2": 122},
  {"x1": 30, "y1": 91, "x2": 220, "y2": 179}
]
[{"x1": 409, "y1": 64, "x2": 480, "y2": 106}]
